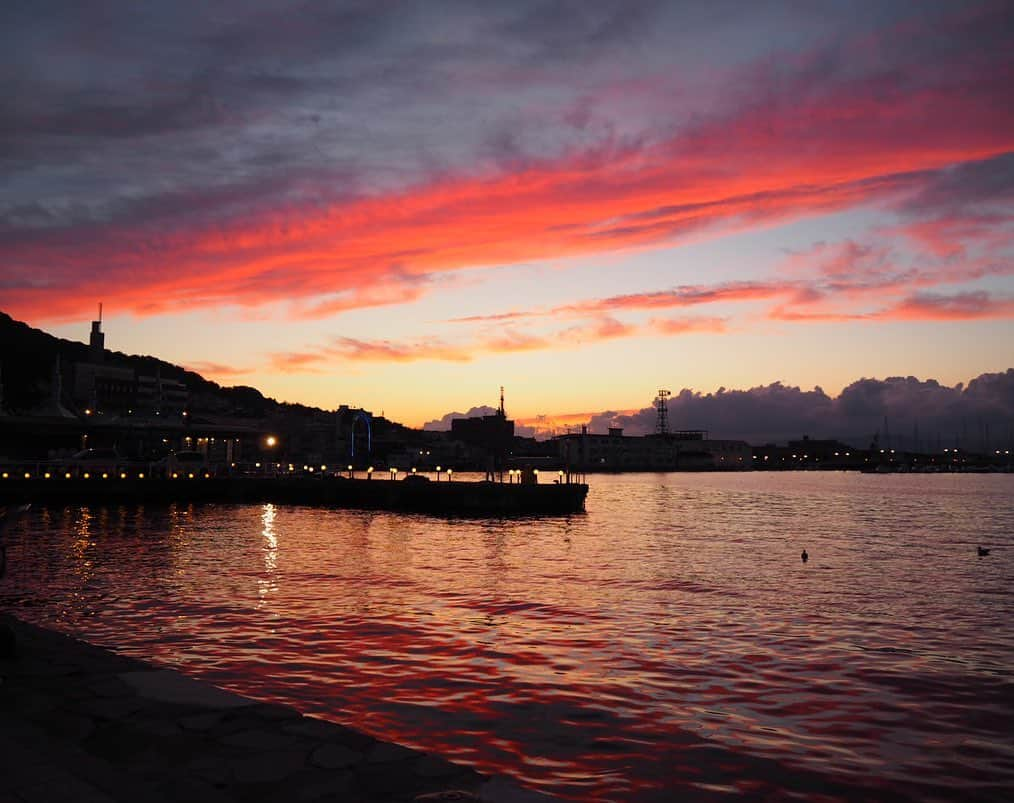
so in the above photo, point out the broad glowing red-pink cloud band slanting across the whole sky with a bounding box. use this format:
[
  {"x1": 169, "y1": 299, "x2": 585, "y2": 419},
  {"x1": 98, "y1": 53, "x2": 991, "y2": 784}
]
[{"x1": 0, "y1": 14, "x2": 1014, "y2": 320}]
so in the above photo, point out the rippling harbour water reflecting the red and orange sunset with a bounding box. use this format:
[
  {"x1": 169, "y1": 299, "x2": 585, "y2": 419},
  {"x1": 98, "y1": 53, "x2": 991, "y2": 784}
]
[{"x1": 0, "y1": 473, "x2": 1014, "y2": 800}]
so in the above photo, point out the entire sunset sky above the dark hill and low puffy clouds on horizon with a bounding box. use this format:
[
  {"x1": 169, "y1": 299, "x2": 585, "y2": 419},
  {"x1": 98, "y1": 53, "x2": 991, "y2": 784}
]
[{"x1": 0, "y1": 0, "x2": 1014, "y2": 425}]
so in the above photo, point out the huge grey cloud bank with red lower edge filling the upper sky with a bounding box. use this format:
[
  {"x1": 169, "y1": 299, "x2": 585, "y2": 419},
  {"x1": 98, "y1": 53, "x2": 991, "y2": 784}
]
[{"x1": 0, "y1": 0, "x2": 1011, "y2": 315}]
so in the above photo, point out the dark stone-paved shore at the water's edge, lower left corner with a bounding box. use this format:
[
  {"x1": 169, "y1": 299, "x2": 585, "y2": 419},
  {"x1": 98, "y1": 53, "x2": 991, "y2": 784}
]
[{"x1": 0, "y1": 616, "x2": 550, "y2": 803}]
